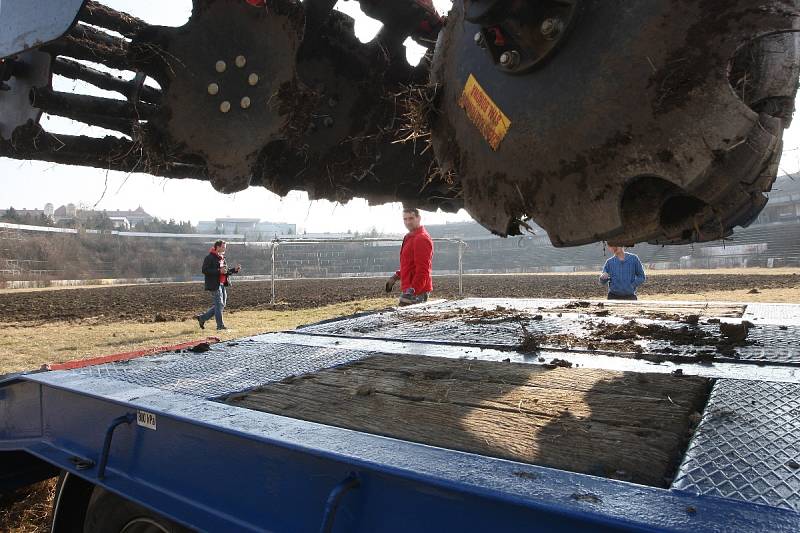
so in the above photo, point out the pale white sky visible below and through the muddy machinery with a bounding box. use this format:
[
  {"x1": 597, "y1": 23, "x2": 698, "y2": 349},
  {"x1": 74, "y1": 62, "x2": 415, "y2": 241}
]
[{"x1": 0, "y1": 0, "x2": 800, "y2": 233}]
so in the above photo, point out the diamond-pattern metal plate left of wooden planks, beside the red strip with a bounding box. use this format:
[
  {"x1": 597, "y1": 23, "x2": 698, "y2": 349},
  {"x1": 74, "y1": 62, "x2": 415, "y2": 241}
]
[{"x1": 72, "y1": 335, "x2": 372, "y2": 398}]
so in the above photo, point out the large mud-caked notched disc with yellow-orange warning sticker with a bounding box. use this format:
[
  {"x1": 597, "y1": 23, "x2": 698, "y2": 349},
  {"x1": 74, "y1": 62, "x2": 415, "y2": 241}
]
[{"x1": 432, "y1": 0, "x2": 800, "y2": 245}]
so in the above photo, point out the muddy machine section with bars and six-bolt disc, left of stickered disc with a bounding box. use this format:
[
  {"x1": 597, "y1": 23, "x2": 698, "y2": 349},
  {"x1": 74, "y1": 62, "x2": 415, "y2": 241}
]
[{"x1": 0, "y1": 0, "x2": 461, "y2": 210}]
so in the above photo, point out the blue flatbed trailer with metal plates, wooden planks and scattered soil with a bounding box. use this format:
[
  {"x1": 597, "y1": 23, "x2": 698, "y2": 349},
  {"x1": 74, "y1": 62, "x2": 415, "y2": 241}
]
[{"x1": 0, "y1": 299, "x2": 800, "y2": 533}]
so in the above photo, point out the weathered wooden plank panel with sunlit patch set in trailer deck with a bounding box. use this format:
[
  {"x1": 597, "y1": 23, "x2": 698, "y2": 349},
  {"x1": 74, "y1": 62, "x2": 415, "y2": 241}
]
[{"x1": 227, "y1": 355, "x2": 709, "y2": 486}]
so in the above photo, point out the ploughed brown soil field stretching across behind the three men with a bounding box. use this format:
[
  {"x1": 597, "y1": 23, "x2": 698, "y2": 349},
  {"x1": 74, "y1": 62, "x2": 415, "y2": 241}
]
[{"x1": 0, "y1": 273, "x2": 800, "y2": 325}]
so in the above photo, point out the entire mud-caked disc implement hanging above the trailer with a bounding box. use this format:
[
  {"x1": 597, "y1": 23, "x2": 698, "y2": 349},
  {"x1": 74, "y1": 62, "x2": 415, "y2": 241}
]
[{"x1": 0, "y1": 0, "x2": 800, "y2": 245}]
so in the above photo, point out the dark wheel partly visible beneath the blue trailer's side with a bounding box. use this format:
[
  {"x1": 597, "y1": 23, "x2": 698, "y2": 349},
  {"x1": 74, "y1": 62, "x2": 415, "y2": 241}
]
[{"x1": 83, "y1": 487, "x2": 191, "y2": 533}]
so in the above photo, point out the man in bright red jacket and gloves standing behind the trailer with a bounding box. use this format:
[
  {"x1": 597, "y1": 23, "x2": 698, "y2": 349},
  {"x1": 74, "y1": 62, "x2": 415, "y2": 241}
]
[{"x1": 386, "y1": 208, "x2": 433, "y2": 305}]
